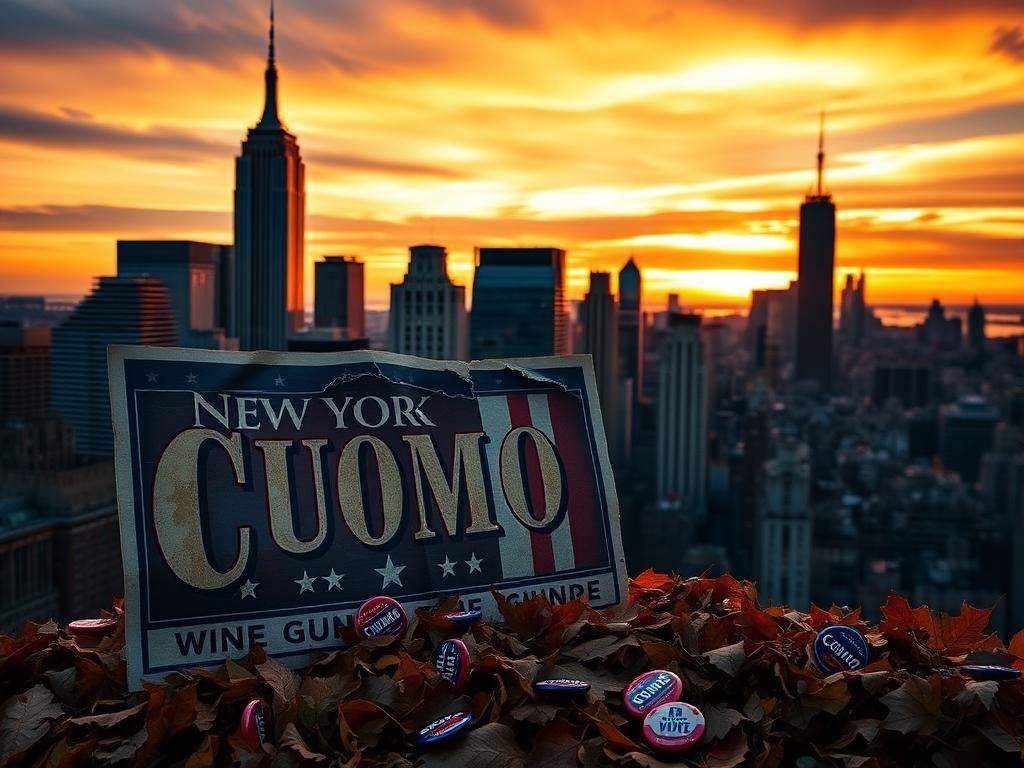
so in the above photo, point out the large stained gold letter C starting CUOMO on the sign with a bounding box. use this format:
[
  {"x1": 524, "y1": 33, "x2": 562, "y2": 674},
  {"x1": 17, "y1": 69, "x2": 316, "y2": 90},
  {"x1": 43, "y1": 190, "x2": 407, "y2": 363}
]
[{"x1": 153, "y1": 429, "x2": 250, "y2": 590}]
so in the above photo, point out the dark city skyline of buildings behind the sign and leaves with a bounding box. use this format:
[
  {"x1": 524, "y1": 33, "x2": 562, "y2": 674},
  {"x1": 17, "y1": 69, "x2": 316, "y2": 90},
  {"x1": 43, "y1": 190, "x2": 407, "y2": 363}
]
[{"x1": 6, "y1": 4, "x2": 1024, "y2": 637}]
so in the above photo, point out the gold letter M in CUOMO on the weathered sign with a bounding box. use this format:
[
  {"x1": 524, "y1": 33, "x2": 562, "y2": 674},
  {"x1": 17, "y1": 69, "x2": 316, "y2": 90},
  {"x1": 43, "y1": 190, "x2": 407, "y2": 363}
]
[{"x1": 401, "y1": 432, "x2": 500, "y2": 539}]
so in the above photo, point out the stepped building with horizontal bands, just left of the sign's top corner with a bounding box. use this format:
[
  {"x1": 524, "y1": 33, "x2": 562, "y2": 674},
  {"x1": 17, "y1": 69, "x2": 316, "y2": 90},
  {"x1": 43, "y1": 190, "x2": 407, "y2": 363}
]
[{"x1": 50, "y1": 276, "x2": 177, "y2": 456}]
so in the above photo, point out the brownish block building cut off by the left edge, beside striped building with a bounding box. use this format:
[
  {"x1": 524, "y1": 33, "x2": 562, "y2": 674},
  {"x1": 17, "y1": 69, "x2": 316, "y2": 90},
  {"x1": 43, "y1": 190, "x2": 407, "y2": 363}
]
[{"x1": 0, "y1": 323, "x2": 50, "y2": 424}]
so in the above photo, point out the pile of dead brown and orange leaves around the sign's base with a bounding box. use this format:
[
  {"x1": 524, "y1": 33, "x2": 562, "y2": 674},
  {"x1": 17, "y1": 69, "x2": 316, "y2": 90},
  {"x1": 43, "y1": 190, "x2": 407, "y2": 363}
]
[{"x1": 0, "y1": 571, "x2": 1024, "y2": 768}]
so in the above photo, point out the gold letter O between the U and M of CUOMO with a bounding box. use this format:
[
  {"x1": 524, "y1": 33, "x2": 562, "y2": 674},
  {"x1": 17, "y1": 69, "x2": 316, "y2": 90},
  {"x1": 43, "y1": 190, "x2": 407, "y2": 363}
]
[{"x1": 338, "y1": 434, "x2": 401, "y2": 547}]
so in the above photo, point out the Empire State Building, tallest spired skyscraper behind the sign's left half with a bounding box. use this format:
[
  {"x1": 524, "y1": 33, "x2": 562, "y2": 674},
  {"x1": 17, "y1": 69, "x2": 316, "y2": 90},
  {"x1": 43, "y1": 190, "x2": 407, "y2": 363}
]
[{"x1": 234, "y1": 2, "x2": 305, "y2": 350}]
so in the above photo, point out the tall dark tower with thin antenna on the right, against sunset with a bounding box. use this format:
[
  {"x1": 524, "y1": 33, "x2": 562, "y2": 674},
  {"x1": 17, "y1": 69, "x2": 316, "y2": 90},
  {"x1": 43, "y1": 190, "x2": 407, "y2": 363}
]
[{"x1": 795, "y1": 117, "x2": 836, "y2": 392}]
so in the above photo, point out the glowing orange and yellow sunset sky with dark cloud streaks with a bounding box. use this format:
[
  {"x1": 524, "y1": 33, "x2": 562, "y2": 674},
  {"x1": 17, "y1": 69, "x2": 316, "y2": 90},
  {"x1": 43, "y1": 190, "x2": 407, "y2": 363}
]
[{"x1": 0, "y1": 0, "x2": 1024, "y2": 307}]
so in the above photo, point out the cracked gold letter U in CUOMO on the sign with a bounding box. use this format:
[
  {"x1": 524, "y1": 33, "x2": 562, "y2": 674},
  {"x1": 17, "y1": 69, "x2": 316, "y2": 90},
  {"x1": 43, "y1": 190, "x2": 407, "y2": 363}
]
[{"x1": 255, "y1": 440, "x2": 327, "y2": 555}]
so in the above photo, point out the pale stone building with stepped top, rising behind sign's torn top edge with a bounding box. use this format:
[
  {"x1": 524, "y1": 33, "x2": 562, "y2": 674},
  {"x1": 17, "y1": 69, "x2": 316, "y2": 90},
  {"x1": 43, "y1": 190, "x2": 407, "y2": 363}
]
[{"x1": 388, "y1": 245, "x2": 469, "y2": 360}]
